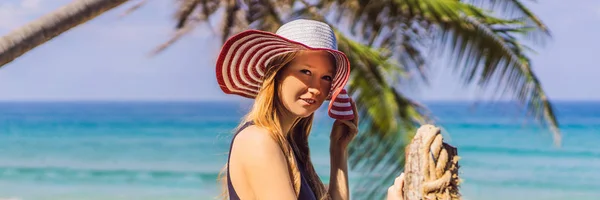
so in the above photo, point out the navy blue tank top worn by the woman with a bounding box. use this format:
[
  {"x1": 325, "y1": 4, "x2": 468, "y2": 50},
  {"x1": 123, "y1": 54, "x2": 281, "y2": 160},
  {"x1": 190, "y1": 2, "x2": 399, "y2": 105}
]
[{"x1": 227, "y1": 122, "x2": 317, "y2": 200}]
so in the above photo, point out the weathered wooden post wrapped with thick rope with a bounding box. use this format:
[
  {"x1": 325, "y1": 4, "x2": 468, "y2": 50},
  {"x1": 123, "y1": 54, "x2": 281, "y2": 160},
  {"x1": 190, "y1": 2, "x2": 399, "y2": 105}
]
[{"x1": 404, "y1": 125, "x2": 460, "y2": 200}]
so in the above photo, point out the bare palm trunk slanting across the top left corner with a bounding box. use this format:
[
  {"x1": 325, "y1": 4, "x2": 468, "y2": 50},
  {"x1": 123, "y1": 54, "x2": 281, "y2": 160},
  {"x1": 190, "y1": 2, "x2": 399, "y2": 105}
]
[{"x1": 0, "y1": 0, "x2": 128, "y2": 67}]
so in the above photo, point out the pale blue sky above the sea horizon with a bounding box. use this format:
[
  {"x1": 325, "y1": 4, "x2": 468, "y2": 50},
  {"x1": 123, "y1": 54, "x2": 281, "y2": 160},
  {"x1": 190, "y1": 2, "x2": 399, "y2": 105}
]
[{"x1": 0, "y1": 0, "x2": 600, "y2": 101}]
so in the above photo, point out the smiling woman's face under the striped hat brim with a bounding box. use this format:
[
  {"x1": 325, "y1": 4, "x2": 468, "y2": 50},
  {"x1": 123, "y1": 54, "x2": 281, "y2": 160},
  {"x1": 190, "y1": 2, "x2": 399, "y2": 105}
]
[{"x1": 279, "y1": 51, "x2": 335, "y2": 117}]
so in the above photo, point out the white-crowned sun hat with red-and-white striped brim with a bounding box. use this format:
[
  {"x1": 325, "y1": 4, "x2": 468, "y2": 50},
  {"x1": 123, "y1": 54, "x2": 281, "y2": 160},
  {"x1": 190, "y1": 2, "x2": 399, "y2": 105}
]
[{"x1": 216, "y1": 19, "x2": 350, "y2": 119}]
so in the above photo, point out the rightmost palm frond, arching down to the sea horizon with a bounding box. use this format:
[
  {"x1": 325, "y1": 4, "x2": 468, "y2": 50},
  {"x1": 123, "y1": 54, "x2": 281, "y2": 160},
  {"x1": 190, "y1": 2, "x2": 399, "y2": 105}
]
[{"x1": 426, "y1": 4, "x2": 561, "y2": 144}]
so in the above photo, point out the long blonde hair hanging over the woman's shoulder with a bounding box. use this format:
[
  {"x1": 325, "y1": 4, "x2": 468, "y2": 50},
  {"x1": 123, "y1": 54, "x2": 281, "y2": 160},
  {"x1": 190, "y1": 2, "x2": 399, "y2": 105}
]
[{"x1": 219, "y1": 52, "x2": 330, "y2": 199}]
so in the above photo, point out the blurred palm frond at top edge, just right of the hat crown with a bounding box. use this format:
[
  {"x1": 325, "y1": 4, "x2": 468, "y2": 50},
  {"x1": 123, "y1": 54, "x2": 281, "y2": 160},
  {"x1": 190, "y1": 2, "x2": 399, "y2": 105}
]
[{"x1": 321, "y1": 0, "x2": 438, "y2": 84}]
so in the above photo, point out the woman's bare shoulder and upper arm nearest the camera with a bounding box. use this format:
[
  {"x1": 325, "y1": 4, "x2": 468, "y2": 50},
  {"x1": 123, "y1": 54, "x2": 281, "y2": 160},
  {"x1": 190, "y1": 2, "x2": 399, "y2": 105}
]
[{"x1": 230, "y1": 126, "x2": 297, "y2": 200}]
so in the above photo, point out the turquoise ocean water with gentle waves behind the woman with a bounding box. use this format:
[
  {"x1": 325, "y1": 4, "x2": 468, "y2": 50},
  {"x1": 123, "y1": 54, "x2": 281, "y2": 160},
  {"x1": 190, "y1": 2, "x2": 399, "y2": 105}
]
[{"x1": 0, "y1": 102, "x2": 600, "y2": 200}]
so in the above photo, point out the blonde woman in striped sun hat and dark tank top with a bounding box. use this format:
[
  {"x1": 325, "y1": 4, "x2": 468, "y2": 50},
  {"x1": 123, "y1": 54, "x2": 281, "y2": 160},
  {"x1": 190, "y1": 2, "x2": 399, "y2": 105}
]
[{"x1": 216, "y1": 20, "x2": 404, "y2": 199}]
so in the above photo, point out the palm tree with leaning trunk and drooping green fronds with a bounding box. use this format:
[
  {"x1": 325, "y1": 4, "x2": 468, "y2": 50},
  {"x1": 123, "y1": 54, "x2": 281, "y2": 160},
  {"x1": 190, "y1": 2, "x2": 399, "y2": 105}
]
[{"x1": 0, "y1": 0, "x2": 560, "y2": 199}]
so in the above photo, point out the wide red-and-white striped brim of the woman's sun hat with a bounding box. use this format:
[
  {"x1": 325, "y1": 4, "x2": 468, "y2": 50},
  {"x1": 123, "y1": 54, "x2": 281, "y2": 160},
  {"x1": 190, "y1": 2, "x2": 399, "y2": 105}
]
[{"x1": 216, "y1": 30, "x2": 350, "y2": 111}]
